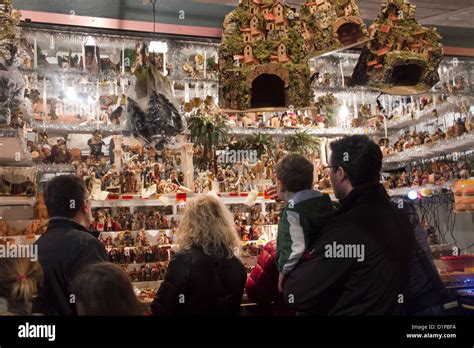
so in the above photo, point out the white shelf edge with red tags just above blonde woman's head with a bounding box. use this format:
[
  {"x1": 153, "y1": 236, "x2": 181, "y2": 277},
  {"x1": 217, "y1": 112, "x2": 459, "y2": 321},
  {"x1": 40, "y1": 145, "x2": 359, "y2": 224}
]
[{"x1": 91, "y1": 191, "x2": 275, "y2": 208}]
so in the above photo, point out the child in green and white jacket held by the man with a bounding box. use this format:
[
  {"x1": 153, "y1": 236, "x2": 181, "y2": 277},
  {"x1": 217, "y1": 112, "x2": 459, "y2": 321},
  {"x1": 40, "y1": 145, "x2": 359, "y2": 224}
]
[{"x1": 275, "y1": 154, "x2": 334, "y2": 292}]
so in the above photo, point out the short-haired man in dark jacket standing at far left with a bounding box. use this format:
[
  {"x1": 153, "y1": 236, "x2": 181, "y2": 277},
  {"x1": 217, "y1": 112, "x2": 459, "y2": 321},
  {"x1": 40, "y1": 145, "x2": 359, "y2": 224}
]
[{"x1": 36, "y1": 175, "x2": 107, "y2": 315}]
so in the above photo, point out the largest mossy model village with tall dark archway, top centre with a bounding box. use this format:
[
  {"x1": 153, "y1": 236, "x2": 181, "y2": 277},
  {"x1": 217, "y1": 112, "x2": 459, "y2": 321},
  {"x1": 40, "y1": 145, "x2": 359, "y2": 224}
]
[{"x1": 218, "y1": 0, "x2": 311, "y2": 110}]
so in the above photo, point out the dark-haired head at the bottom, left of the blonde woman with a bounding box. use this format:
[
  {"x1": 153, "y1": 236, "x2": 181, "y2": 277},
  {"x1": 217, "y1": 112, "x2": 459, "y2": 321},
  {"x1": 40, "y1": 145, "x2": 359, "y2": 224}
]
[{"x1": 72, "y1": 262, "x2": 145, "y2": 316}]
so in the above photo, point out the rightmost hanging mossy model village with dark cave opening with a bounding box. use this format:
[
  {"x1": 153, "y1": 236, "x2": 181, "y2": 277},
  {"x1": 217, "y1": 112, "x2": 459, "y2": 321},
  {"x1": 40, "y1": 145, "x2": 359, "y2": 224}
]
[{"x1": 352, "y1": 0, "x2": 443, "y2": 95}]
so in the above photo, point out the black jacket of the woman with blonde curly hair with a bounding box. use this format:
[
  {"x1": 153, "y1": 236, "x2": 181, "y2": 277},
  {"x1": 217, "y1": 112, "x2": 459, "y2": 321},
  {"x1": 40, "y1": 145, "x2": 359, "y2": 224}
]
[{"x1": 151, "y1": 247, "x2": 247, "y2": 315}]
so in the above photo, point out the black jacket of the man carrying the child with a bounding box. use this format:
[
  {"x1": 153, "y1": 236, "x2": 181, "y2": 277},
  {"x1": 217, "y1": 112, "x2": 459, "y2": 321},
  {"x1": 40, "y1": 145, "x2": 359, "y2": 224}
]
[{"x1": 284, "y1": 183, "x2": 414, "y2": 315}]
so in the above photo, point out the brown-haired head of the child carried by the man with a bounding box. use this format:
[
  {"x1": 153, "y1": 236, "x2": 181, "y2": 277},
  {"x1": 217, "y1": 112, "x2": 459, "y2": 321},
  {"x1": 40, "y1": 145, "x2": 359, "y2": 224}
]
[{"x1": 275, "y1": 153, "x2": 314, "y2": 201}]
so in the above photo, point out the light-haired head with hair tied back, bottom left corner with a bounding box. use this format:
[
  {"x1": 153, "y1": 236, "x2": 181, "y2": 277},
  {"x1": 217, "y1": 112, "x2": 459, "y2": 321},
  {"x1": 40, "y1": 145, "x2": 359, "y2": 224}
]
[{"x1": 0, "y1": 258, "x2": 43, "y2": 315}]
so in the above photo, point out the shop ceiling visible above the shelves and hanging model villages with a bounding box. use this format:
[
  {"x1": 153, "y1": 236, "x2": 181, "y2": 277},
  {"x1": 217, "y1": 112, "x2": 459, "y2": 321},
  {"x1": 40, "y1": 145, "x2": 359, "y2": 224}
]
[{"x1": 13, "y1": 0, "x2": 474, "y2": 48}]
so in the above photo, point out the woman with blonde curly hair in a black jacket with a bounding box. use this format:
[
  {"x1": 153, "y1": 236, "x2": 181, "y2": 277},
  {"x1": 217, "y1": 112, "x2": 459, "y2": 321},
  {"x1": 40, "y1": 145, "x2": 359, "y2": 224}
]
[{"x1": 152, "y1": 196, "x2": 247, "y2": 315}]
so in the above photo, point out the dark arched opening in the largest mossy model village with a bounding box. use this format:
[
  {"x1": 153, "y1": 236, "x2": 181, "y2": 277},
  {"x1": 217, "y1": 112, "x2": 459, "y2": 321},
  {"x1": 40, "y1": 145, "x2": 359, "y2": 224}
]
[{"x1": 250, "y1": 74, "x2": 286, "y2": 108}]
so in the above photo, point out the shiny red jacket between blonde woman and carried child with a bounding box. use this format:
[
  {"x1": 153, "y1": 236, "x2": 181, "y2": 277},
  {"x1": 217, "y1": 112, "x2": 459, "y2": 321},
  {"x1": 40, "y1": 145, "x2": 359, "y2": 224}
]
[{"x1": 245, "y1": 240, "x2": 293, "y2": 315}]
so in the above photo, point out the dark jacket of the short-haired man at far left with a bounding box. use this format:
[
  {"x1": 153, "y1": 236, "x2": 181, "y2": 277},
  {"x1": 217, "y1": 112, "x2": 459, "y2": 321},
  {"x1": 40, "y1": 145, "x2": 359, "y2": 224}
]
[{"x1": 36, "y1": 218, "x2": 107, "y2": 315}]
